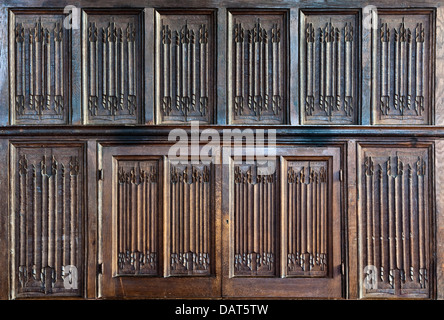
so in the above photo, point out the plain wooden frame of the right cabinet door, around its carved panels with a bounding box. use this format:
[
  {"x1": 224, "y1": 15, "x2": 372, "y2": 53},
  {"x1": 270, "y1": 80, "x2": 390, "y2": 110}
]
[{"x1": 222, "y1": 145, "x2": 344, "y2": 298}]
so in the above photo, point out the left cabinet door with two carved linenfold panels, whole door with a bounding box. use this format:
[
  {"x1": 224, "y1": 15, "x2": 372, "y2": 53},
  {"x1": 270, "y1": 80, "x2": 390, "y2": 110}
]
[{"x1": 99, "y1": 144, "x2": 220, "y2": 298}]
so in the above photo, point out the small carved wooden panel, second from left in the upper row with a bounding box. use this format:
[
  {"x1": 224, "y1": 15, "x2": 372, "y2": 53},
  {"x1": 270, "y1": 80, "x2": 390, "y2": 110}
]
[{"x1": 82, "y1": 10, "x2": 143, "y2": 124}]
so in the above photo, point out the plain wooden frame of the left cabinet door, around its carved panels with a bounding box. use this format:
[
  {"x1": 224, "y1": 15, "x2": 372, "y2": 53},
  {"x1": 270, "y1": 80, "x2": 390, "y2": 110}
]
[{"x1": 99, "y1": 142, "x2": 221, "y2": 299}]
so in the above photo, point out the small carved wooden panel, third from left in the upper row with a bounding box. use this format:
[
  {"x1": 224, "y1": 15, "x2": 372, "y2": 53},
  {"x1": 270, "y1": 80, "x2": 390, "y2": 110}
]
[{"x1": 156, "y1": 10, "x2": 215, "y2": 123}]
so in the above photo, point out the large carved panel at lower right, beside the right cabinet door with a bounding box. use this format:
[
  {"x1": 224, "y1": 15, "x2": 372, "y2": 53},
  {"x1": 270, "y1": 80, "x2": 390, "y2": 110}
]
[{"x1": 359, "y1": 148, "x2": 433, "y2": 298}]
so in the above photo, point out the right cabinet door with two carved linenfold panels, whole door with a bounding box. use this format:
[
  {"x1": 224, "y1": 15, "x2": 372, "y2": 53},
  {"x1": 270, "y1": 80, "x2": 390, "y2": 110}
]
[{"x1": 222, "y1": 146, "x2": 342, "y2": 298}]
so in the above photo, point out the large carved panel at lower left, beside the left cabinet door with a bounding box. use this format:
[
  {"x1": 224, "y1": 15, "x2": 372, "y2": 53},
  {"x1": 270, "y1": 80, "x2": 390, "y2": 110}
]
[{"x1": 12, "y1": 145, "x2": 84, "y2": 297}]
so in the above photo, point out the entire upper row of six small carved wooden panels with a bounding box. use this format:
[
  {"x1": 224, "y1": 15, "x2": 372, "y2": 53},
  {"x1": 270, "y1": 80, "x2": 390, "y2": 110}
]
[{"x1": 9, "y1": 9, "x2": 436, "y2": 125}]
